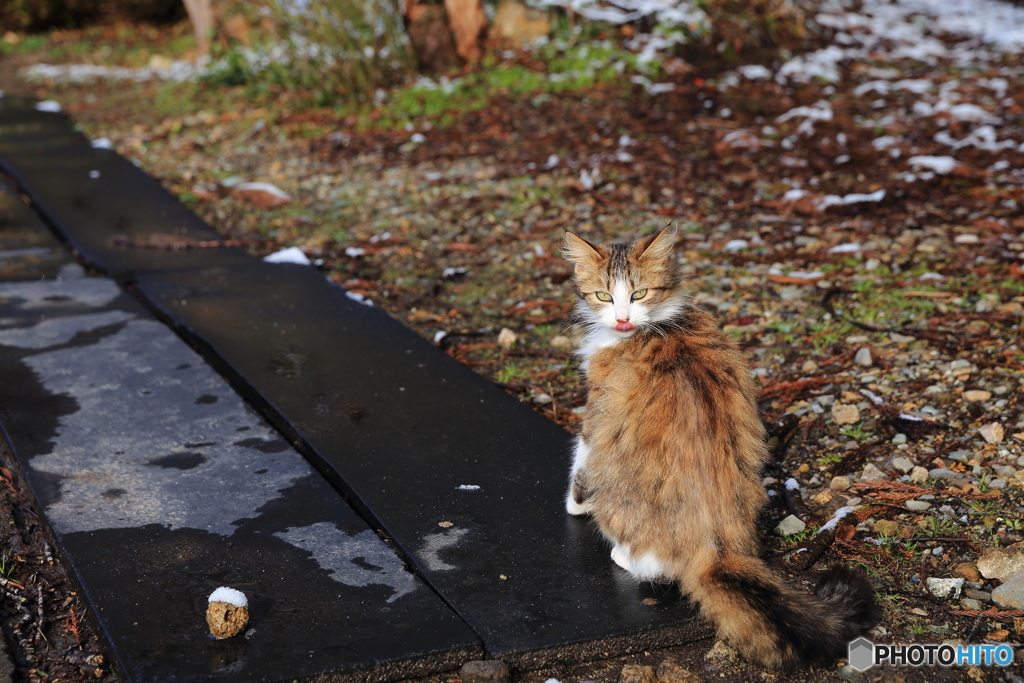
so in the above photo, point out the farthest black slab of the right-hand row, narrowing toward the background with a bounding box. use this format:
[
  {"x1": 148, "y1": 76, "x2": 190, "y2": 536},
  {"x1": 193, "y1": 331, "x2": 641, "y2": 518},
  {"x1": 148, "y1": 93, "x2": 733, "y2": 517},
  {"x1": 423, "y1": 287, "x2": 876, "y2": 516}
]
[{"x1": 0, "y1": 98, "x2": 249, "y2": 281}]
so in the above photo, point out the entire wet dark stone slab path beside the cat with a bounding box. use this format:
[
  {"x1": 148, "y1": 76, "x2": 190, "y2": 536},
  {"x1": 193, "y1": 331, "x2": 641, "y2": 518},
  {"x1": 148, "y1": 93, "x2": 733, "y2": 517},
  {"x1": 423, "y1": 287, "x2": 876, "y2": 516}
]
[{"x1": 0, "y1": 99, "x2": 706, "y2": 680}]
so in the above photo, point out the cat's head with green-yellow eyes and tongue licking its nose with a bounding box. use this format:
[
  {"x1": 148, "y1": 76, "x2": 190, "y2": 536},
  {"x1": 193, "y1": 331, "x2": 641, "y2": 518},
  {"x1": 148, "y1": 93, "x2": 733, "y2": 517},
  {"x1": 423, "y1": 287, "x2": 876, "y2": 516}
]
[{"x1": 565, "y1": 228, "x2": 680, "y2": 338}]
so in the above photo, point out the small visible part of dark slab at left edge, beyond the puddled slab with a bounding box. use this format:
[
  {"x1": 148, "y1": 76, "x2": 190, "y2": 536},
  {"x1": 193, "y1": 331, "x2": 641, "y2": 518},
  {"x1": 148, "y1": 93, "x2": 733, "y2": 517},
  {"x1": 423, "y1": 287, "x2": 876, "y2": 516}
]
[{"x1": 0, "y1": 179, "x2": 75, "y2": 282}]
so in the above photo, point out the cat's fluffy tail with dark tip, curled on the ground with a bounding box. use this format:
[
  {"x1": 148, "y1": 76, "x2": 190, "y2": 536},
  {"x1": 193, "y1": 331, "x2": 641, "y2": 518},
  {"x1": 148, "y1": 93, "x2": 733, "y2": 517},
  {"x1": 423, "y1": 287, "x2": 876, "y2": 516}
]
[{"x1": 682, "y1": 556, "x2": 880, "y2": 669}]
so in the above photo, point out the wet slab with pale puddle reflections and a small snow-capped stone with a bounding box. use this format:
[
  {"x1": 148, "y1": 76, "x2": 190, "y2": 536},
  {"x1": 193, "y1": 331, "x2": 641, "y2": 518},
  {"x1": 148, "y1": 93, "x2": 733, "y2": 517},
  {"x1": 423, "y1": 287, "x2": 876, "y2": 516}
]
[{"x1": 0, "y1": 276, "x2": 482, "y2": 683}]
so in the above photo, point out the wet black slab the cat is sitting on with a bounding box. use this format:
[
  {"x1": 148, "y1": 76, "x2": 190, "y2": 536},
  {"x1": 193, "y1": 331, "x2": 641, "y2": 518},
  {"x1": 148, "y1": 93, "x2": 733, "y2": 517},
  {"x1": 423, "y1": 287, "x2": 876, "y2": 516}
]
[{"x1": 138, "y1": 262, "x2": 707, "y2": 666}]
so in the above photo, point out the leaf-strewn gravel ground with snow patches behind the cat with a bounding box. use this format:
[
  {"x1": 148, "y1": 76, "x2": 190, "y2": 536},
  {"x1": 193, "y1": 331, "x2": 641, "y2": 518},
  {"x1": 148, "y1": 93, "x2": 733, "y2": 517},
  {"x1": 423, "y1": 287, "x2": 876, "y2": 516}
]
[{"x1": 0, "y1": 2, "x2": 1024, "y2": 683}]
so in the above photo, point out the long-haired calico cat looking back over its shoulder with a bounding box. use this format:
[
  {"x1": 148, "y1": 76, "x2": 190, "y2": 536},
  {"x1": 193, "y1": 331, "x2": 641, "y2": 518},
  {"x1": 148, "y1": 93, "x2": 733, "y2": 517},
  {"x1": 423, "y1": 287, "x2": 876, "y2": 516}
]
[{"x1": 565, "y1": 228, "x2": 879, "y2": 668}]
